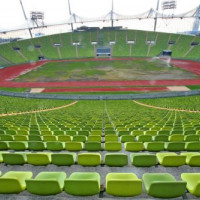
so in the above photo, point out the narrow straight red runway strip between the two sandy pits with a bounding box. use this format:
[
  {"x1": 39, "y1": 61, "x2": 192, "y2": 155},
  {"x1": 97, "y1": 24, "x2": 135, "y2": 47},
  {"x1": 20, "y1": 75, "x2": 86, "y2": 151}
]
[{"x1": 42, "y1": 87, "x2": 168, "y2": 93}]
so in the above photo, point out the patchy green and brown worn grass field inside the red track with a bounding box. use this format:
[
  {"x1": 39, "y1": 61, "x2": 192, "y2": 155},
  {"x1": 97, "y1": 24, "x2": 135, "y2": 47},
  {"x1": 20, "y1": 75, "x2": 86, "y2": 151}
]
[{"x1": 15, "y1": 60, "x2": 198, "y2": 82}]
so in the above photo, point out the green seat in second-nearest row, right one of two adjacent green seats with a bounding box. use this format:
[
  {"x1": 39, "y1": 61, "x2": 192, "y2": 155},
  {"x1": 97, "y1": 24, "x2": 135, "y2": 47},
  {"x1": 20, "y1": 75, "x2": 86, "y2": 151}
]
[{"x1": 130, "y1": 153, "x2": 156, "y2": 167}]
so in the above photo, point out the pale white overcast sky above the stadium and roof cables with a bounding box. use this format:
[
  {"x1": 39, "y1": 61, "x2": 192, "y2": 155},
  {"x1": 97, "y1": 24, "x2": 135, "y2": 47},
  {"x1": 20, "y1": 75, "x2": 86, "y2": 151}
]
[{"x1": 0, "y1": 0, "x2": 200, "y2": 32}]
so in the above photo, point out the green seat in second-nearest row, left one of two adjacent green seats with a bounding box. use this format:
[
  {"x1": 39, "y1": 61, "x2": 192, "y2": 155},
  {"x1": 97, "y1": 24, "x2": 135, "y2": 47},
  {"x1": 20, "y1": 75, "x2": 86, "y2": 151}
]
[{"x1": 104, "y1": 153, "x2": 128, "y2": 167}]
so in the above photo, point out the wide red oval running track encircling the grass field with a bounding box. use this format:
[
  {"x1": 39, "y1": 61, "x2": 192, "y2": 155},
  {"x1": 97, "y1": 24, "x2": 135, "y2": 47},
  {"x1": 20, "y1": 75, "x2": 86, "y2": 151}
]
[{"x1": 0, "y1": 58, "x2": 200, "y2": 88}]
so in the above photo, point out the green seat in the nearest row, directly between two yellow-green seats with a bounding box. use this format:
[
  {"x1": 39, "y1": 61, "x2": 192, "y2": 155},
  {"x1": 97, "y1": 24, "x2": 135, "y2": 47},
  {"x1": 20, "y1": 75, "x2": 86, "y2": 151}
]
[{"x1": 142, "y1": 173, "x2": 186, "y2": 198}]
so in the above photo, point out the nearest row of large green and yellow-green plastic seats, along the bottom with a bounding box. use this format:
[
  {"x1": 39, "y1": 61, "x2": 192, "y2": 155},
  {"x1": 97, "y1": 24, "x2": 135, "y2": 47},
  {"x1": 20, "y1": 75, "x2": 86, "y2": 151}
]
[{"x1": 0, "y1": 171, "x2": 200, "y2": 198}]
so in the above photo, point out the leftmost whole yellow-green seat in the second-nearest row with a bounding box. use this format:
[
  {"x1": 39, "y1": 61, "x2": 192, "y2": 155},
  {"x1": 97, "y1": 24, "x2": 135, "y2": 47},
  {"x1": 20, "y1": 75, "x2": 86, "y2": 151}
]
[{"x1": 27, "y1": 152, "x2": 51, "y2": 165}]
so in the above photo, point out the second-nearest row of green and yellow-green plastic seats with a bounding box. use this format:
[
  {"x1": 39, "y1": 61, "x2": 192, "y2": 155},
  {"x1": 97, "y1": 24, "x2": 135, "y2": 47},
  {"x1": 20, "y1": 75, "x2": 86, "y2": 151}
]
[{"x1": 0, "y1": 152, "x2": 200, "y2": 167}]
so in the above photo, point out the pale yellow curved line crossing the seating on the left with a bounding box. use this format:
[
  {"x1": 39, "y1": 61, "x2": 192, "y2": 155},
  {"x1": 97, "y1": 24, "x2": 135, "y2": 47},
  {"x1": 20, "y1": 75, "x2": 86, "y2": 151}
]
[{"x1": 0, "y1": 101, "x2": 78, "y2": 117}]
